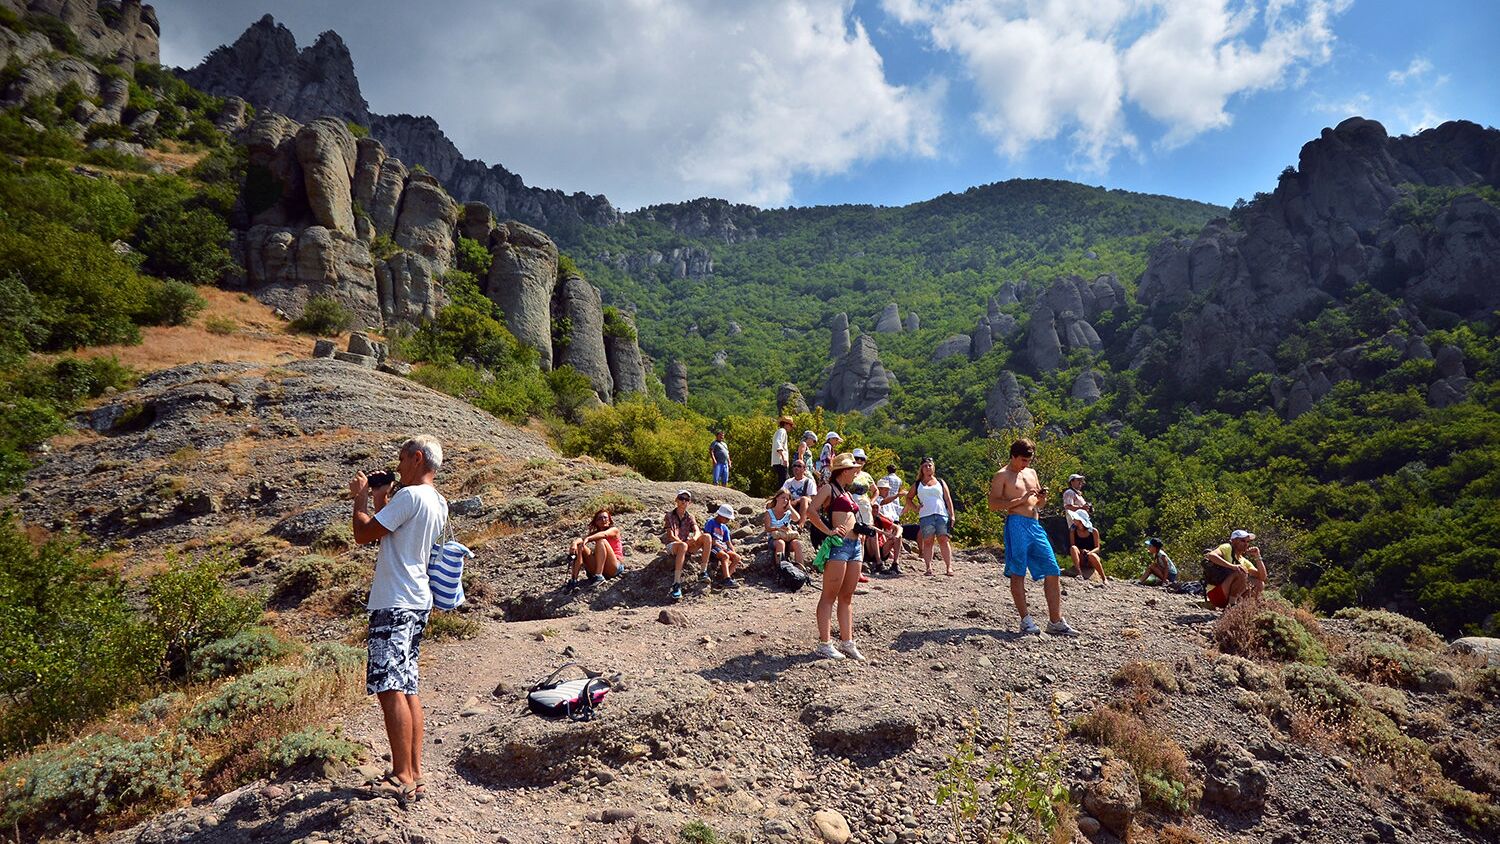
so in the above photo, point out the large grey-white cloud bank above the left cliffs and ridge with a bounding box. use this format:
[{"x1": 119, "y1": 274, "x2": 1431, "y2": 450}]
[{"x1": 156, "y1": 0, "x2": 942, "y2": 207}]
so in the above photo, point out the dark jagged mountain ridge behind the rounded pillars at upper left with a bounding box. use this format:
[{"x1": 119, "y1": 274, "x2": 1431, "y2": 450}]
[{"x1": 178, "y1": 15, "x2": 620, "y2": 236}]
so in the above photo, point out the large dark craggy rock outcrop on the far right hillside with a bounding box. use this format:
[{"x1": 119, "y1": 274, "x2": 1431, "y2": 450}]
[{"x1": 1137, "y1": 117, "x2": 1500, "y2": 409}]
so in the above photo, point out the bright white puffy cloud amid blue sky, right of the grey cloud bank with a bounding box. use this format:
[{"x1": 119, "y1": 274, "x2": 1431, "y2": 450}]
[{"x1": 884, "y1": 0, "x2": 1349, "y2": 171}]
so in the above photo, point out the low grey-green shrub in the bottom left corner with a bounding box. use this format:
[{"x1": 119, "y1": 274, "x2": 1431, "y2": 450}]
[{"x1": 0, "y1": 735, "x2": 203, "y2": 829}]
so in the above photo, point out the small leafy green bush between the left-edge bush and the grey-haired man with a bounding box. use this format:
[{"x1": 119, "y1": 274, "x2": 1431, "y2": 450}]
[{"x1": 146, "y1": 555, "x2": 266, "y2": 676}]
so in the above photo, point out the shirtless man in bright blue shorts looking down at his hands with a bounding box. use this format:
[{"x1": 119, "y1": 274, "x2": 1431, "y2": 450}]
[{"x1": 990, "y1": 439, "x2": 1079, "y2": 636}]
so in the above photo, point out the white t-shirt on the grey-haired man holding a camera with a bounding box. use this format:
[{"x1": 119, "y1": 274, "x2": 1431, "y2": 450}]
[{"x1": 365, "y1": 484, "x2": 449, "y2": 610}]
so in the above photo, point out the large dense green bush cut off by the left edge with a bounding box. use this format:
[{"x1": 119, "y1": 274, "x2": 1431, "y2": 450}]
[{"x1": 0, "y1": 520, "x2": 155, "y2": 750}]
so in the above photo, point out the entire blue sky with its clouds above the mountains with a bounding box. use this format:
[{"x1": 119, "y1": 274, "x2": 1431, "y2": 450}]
[{"x1": 156, "y1": 0, "x2": 1500, "y2": 208}]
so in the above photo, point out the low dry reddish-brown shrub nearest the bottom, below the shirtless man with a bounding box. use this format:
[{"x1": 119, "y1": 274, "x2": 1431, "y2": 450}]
[{"x1": 1073, "y1": 708, "x2": 1203, "y2": 813}]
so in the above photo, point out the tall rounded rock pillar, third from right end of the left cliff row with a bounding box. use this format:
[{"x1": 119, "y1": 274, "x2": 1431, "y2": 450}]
[{"x1": 485, "y1": 220, "x2": 561, "y2": 372}]
